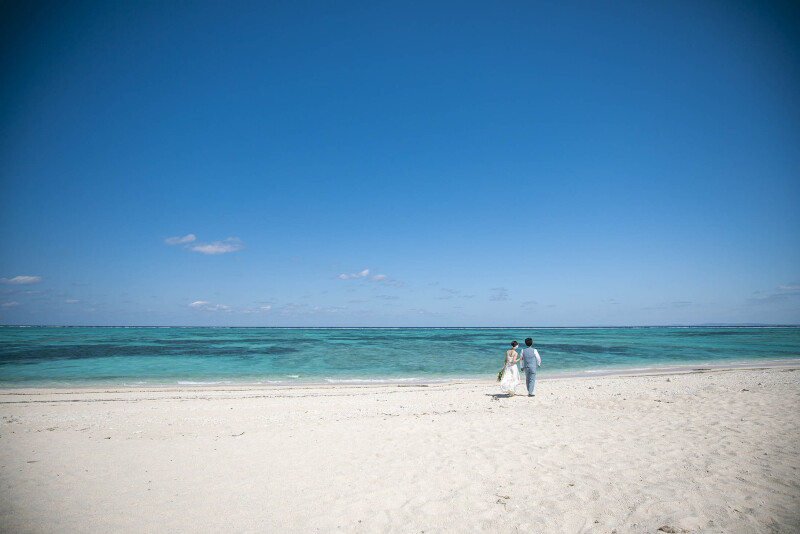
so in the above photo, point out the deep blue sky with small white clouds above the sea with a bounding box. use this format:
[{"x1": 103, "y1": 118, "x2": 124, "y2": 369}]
[{"x1": 0, "y1": 2, "x2": 800, "y2": 326}]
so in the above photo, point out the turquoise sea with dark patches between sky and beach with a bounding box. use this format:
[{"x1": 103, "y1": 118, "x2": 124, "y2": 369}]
[{"x1": 0, "y1": 327, "x2": 800, "y2": 387}]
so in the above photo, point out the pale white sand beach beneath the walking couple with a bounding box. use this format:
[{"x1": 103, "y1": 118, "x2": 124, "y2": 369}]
[{"x1": 0, "y1": 368, "x2": 800, "y2": 534}]
